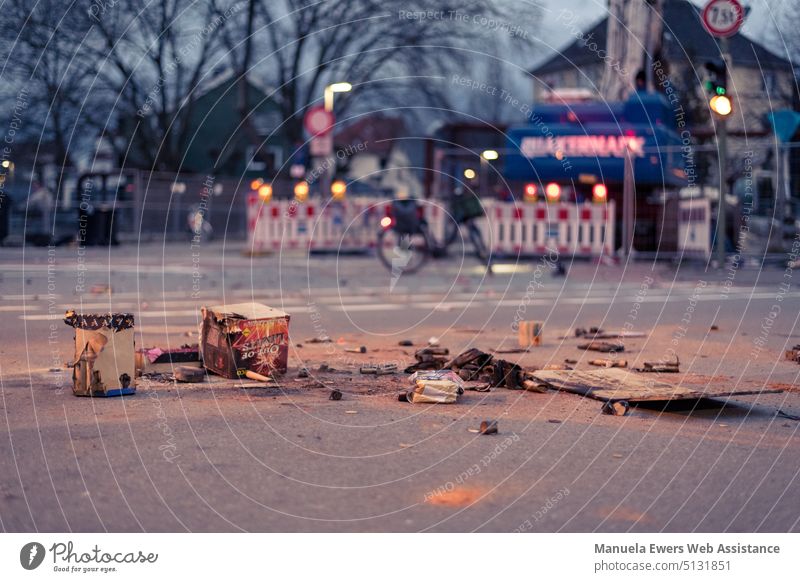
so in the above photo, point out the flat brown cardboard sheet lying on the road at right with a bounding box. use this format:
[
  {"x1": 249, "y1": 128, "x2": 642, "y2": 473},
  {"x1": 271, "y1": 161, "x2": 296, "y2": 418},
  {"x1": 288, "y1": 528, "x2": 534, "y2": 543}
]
[{"x1": 529, "y1": 368, "x2": 781, "y2": 402}]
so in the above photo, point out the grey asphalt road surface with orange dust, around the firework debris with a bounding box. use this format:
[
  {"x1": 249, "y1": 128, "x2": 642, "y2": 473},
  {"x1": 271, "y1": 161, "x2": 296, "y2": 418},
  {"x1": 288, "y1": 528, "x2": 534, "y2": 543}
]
[{"x1": 0, "y1": 243, "x2": 800, "y2": 532}]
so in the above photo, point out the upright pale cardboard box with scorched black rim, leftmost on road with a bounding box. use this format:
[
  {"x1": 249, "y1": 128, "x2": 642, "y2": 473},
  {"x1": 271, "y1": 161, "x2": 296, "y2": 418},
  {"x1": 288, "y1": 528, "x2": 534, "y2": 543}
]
[{"x1": 64, "y1": 311, "x2": 136, "y2": 396}]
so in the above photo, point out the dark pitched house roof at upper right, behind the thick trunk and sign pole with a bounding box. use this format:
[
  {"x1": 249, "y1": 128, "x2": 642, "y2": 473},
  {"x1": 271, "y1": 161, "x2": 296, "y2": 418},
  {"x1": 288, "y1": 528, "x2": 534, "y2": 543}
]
[{"x1": 530, "y1": 0, "x2": 792, "y2": 76}]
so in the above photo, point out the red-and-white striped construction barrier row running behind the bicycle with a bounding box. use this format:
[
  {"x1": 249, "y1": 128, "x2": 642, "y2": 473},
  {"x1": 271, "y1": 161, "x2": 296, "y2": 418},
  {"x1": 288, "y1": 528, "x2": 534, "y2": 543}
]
[{"x1": 247, "y1": 194, "x2": 614, "y2": 256}]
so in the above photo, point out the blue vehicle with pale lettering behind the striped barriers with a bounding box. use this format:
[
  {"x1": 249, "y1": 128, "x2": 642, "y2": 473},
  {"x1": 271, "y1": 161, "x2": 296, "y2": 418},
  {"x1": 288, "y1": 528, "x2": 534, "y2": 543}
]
[{"x1": 503, "y1": 92, "x2": 694, "y2": 251}]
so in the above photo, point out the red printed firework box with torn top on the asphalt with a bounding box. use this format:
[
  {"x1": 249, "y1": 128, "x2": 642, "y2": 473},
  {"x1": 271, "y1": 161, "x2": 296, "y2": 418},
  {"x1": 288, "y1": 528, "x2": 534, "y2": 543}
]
[{"x1": 200, "y1": 303, "x2": 289, "y2": 378}]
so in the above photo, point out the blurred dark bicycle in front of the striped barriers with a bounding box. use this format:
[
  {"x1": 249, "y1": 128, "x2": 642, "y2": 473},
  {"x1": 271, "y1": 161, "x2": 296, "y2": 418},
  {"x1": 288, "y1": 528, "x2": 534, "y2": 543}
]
[{"x1": 377, "y1": 198, "x2": 492, "y2": 275}]
